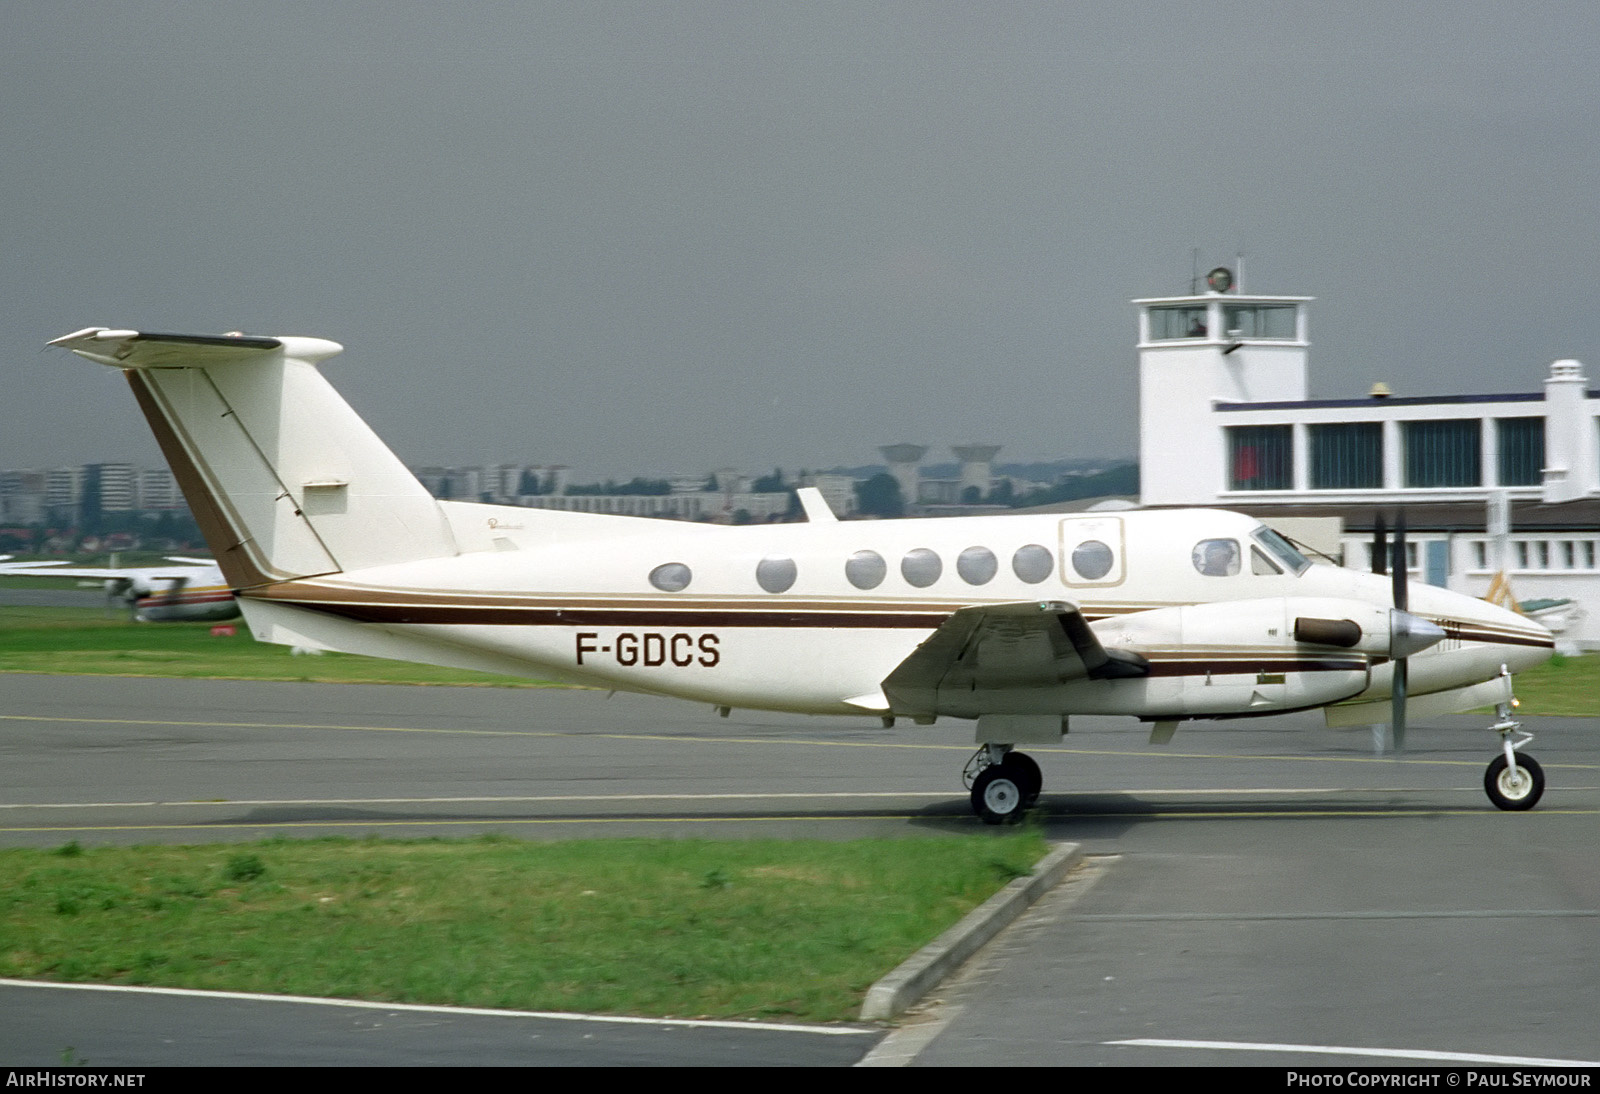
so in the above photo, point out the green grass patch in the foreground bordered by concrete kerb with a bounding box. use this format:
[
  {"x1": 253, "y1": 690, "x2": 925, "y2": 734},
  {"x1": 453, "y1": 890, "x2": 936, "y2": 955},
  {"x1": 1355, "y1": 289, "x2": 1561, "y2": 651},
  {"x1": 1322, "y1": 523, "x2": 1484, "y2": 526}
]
[{"x1": 0, "y1": 830, "x2": 1046, "y2": 1022}]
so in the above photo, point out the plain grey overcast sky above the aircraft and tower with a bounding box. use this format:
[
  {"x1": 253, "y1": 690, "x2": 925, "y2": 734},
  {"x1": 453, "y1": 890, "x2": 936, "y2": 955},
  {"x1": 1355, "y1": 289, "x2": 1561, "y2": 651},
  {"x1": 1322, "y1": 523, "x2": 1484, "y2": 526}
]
[{"x1": 0, "y1": 0, "x2": 1600, "y2": 480}]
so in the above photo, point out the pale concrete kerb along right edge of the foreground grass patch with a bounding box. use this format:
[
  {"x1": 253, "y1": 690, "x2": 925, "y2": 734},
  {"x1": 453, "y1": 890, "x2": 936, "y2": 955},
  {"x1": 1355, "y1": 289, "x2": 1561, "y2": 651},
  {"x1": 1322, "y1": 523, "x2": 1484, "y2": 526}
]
[{"x1": 861, "y1": 843, "x2": 1083, "y2": 1022}]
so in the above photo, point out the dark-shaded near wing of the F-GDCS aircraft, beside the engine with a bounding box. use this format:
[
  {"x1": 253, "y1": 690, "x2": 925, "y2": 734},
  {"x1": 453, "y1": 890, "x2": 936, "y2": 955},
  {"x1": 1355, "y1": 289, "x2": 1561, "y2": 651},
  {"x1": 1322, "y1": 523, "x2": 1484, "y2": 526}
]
[{"x1": 883, "y1": 601, "x2": 1149, "y2": 713}]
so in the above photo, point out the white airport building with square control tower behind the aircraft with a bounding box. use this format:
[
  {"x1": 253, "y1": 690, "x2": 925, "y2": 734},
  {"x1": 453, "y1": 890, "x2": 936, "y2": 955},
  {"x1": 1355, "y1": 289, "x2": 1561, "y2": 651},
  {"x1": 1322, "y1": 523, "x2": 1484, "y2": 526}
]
[{"x1": 1134, "y1": 269, "x2": 1600, "y2": 649}]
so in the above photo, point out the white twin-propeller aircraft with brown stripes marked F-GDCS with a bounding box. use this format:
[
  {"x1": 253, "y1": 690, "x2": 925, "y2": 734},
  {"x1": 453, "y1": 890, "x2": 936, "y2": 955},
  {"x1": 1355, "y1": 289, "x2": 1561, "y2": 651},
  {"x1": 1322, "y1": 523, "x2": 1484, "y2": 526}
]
[{"x1": 51, "y1": 328, "x2": 1554, "y2": 824}]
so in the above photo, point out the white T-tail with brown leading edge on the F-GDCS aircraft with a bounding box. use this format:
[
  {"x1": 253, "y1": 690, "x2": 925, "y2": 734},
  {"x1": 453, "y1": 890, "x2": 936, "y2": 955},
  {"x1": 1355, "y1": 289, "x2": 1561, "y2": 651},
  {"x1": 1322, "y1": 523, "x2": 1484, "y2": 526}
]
[{"x1": 51, "y1": 326, "x2": 458, "y2": 589}]
